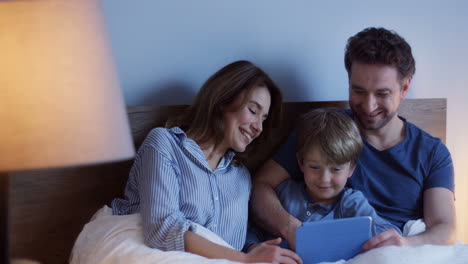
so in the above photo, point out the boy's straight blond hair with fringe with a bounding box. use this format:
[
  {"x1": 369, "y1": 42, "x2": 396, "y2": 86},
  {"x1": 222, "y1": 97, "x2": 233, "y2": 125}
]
[{"x1": 296, "y1": 108, "x2": 363, "y2": 165}]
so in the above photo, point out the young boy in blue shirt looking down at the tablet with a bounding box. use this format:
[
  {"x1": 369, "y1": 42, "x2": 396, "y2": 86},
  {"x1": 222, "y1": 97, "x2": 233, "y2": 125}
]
[{"x1": 244, "y1": 109, "x2": 400, "y2": 249}]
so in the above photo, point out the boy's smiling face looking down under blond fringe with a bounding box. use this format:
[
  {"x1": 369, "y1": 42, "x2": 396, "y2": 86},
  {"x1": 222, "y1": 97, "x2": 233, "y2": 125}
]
[{"x1": 297, "y1": 147, "x2": 354, "y2": 205}]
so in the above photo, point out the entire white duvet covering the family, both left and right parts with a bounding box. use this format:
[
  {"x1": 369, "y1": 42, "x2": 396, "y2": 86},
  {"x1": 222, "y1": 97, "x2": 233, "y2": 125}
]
[{"x1": 70, "y1": 206, "x2": 468, "y2": 264}]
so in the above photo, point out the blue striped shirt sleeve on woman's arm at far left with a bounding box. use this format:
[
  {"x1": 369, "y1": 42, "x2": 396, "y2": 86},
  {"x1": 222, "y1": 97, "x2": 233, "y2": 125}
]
[{"x1": 136, "y1": 145, "x2": 192, "y2": 251}]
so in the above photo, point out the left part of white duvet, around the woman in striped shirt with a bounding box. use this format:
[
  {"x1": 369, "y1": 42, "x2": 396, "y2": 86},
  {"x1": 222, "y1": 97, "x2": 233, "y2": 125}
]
[{"x1": 70, "y1": 206, "x2": 264, "y2": 264}]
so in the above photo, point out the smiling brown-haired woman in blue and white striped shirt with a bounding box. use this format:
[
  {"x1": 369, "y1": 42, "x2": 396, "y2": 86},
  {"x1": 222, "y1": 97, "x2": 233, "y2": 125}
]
[{"x1": 112, "y1": 61, "x2": 300, "y2": 263}]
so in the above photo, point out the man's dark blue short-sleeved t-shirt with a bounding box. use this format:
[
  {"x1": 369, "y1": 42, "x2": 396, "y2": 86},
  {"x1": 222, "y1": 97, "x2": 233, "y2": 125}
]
[{"x1": 274, "y1": 111, "x2": 454, "y2": 229}]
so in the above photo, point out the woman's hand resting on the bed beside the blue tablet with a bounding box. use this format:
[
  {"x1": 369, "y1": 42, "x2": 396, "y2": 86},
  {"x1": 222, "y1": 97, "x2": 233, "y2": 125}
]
[{"x1": 246, "y1": 238, "x2": 302, "y2": 264}]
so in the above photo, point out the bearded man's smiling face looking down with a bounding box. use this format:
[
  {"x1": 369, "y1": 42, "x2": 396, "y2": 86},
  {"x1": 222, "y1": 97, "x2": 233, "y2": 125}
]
[{"x1": 349, "y1": 62, "x2": 411, "y2": 130}]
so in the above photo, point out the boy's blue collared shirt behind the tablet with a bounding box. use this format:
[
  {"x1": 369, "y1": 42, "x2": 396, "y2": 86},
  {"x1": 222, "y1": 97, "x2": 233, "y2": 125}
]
[{"x1": 244, "y1": 179, "x2": 401, "y2": 249}]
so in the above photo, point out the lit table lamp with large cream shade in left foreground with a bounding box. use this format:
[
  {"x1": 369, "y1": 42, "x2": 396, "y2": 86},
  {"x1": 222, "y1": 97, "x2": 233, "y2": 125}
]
[{"x1": 0, "y1": 0, "x2": 135, "y2": 263}]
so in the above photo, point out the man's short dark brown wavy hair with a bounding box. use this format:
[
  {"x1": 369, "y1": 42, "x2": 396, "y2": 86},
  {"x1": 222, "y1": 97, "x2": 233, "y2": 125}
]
[{"x1": 344, "y1": 27, "x2": 416, "y2": 80}]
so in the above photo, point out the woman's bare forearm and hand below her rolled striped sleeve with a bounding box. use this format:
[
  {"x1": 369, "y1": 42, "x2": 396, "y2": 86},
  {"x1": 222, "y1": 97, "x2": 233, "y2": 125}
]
[{"x1": 185, "y1": 231, "x2": 302, "y2": 264}]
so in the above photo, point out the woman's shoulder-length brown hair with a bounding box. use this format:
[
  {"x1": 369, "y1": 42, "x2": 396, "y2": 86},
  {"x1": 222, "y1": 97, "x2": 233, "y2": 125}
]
[{"x1": 166, "y1": 60, "x2": 282, "y2": 161}]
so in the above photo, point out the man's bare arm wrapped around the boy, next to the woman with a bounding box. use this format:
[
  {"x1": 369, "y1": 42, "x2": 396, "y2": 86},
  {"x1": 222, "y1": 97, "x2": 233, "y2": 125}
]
[{"x1": 250, "y1": 160, "x2": 301, "y2": 249}]
